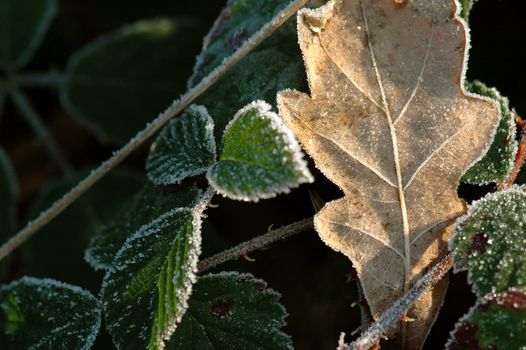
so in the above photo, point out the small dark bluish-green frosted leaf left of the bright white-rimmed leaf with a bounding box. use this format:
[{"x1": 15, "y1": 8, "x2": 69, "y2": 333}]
[{"x1": 146, "y1": 105, "x2": 216, "y2": 185}]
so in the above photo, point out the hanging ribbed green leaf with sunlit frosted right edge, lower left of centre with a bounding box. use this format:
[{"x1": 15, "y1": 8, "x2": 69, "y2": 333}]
[{"x1": 101, "y1": 191, "x2": 212, "y2": 349}]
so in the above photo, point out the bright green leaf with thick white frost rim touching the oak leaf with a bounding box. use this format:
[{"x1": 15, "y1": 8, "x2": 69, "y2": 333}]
[{"x1": 207, "y1": 101, "x2": 313, "y2": 201}]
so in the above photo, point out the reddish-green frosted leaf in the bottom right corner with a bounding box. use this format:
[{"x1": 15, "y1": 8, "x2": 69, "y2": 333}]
[{"x1": 446, "y1": 289, "x2": 526, "y2": 350}]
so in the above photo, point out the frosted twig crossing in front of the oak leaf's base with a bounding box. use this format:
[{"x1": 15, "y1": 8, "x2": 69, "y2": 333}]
[{"x1": 338, "y1": 254, "x2": 453, "y2": 350}]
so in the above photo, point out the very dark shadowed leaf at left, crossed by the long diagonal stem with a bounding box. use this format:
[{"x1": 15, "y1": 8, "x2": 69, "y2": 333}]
[{"x1": 21, "y1": 170, "x2": 145, "y2": 291}]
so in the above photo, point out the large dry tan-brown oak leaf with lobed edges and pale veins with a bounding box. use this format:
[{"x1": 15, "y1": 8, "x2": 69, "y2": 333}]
[{"x1": 278, "y1": 0, "x2": 499, "y2": 349}]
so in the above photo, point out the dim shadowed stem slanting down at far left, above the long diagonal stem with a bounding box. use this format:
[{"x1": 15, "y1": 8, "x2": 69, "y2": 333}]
[{"x1": 7, "y1": 84, "x2": 73, "y2": 174}]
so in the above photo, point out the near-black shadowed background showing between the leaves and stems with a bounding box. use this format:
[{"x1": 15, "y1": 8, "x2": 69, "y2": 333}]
[{"x1": 0, "y1": 0, "x2": 526, "y2": 349}]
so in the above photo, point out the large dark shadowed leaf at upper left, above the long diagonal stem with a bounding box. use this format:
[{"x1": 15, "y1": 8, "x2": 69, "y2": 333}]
[{"x1": 61, "y1": 18, "x2": 205, "y2": 144}]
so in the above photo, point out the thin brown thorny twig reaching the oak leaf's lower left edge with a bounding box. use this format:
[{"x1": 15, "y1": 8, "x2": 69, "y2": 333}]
[{"x1": 197, "y1": 218, "x2": 314, "y2": 272}]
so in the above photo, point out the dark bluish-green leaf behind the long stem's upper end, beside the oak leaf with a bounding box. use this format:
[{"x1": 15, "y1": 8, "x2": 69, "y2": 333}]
[{"x1": 192, "y1": 0, "x2": 307, "y2": 140}]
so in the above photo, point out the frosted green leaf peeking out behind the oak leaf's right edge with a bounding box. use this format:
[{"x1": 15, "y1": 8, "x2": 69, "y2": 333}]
[{"x1": 462, "y1": 81, "x2": 517, "y2": 185}]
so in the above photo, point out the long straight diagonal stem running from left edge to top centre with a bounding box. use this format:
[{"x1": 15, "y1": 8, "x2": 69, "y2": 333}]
[{"x1": 0, "y1": 0, "x2": 308, "y2": 260}]
